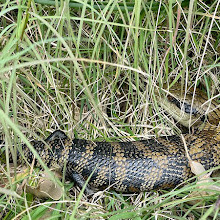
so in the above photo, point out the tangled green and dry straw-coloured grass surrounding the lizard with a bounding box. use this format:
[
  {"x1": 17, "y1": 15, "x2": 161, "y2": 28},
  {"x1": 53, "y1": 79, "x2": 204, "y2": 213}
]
[{"x1": 0, "y1": 0, "x2": 220, "y2": 220}]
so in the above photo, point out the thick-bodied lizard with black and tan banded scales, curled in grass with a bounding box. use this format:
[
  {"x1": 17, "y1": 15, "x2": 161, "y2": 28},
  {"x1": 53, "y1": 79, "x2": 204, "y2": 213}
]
[{"x1": 1, "y1": 88, "x2": 220, "y2": 194}]
